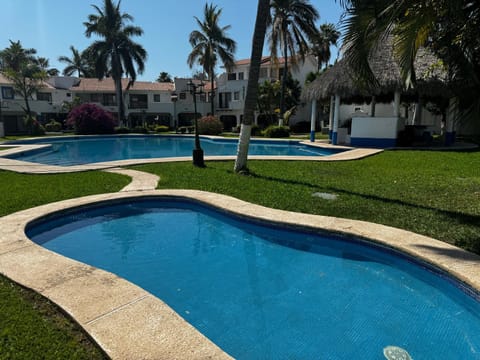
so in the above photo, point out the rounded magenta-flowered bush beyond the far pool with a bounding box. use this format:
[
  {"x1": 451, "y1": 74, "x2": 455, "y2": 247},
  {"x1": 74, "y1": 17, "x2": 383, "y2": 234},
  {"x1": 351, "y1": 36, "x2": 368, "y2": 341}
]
[{"x1": 67, "y1": 104, "x2": 115, "y2": 135}]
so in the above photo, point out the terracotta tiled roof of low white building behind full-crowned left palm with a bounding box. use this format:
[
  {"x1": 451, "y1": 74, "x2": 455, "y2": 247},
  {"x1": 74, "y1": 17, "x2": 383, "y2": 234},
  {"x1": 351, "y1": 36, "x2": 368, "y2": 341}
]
[{"x1": 70, "y1": 78, "x2": 174, "y2": 92}]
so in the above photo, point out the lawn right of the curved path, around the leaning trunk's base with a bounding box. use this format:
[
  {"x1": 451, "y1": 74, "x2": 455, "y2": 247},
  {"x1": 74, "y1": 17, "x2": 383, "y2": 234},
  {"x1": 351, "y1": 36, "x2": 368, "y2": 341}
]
[{"x1": 135, "y1": 151, "x2": 480, "y2": 254}]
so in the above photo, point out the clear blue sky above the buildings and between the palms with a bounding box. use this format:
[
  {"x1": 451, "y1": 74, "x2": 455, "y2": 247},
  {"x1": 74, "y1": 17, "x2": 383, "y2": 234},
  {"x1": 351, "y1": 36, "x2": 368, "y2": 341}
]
[{"x1": 0, "y1": 0, "x2": 342, "y2": 81}]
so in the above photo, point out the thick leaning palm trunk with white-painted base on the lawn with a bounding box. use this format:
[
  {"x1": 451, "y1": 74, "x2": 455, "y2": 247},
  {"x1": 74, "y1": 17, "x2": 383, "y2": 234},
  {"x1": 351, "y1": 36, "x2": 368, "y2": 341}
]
[{"x1": 234, "y1": 0, "x2": 270, "y2": 173}]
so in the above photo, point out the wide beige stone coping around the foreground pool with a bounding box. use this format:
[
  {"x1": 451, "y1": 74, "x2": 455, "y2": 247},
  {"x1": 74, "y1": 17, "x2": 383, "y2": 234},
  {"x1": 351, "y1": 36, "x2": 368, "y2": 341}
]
[{"x1": 0, "y1": 190, "x2": 480, "y2": 359}]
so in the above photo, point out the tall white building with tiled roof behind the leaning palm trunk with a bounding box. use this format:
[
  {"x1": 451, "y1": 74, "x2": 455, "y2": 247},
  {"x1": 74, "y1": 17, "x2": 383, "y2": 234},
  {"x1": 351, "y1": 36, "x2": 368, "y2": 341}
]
[{"x1": 216, "y1": 56, "x2": 317, "y2": 130}]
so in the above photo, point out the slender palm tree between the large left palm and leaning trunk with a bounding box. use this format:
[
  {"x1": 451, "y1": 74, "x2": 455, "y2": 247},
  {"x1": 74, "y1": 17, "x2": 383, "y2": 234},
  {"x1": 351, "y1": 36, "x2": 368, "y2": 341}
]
[{"x1": 187, "y1": 4, "x2": 237, "y2": 115}]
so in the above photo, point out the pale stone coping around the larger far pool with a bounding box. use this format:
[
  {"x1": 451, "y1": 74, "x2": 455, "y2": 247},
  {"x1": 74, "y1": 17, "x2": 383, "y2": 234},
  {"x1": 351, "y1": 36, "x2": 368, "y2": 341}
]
[{"x1": 0, "y1": 135, "x2": 384, "y2": 174}]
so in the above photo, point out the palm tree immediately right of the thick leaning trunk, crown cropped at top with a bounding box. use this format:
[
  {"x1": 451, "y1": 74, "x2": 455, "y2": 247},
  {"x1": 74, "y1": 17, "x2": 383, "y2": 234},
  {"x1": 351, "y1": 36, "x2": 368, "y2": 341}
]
[{"x1": 269, "y1": 0, "x2": 319, "y2": 118}]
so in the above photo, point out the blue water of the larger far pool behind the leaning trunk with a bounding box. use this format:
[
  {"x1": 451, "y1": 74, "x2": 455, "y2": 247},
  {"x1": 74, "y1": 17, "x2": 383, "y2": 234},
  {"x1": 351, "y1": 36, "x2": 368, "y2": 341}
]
[{"x1": 4, "y1": 136, "x2": 340, "y2": 166}]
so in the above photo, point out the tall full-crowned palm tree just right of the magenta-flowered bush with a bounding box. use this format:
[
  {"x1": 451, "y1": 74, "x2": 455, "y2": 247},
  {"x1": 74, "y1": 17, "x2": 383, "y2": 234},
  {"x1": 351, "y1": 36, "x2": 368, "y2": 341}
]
[{"x1": 84, "y1": 0, "x2": 147, "y2": 122}]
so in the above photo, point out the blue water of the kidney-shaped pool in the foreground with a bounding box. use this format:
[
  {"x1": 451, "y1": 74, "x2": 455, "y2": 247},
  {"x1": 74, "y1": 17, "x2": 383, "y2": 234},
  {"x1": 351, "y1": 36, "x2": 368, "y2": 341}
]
[{"x1": 27, "y1": 198, "x2": 480, "y2": 359}]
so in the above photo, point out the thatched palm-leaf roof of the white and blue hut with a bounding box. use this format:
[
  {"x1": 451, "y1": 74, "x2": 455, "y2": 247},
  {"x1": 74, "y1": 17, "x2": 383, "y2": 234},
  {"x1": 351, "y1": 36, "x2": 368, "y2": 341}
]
[{"x1": 302, "y1": 37, "x2": 449, "y2": 101}]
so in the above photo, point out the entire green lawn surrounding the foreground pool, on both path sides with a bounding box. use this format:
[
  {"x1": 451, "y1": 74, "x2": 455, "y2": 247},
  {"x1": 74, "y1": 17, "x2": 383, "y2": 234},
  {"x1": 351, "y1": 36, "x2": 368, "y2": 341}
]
[{"x1": 0, "y1": 151, "x2": 480, "y2": 359}]
